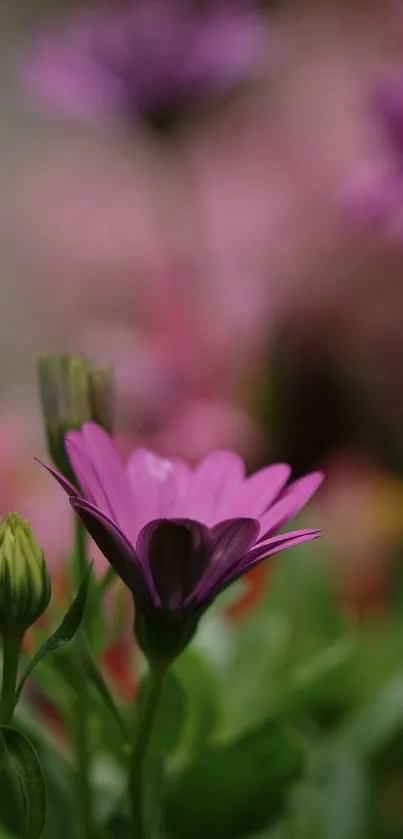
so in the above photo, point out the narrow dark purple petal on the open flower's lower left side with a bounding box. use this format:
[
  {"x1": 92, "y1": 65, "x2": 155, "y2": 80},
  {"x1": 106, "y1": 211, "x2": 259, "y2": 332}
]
[{"x1": 70, "y1": 498, "x2": 146, "y2": 594}]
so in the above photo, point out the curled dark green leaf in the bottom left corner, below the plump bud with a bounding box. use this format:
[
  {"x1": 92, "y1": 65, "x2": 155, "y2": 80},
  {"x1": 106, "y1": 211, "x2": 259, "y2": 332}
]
[{"x1": 0, "y1": 725, "x2": 46, "y2": 839}]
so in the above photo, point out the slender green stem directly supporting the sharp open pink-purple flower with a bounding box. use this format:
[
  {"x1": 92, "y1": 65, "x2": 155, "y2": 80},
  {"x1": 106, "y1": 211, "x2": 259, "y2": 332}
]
[{"x1": 129, "y1": 666, "x2": 167, "y2": 839}]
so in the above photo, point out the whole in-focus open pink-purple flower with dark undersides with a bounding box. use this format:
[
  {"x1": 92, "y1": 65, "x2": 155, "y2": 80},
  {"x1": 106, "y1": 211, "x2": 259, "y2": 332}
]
[{"x1": 43, "y1": 423, "x2": 323, "y2": 658}]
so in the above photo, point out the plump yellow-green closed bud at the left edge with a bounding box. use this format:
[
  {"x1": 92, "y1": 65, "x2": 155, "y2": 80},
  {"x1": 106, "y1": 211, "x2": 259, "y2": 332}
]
[{"x1": 0, "y1": 513, "x2": 51, "y2": 635}]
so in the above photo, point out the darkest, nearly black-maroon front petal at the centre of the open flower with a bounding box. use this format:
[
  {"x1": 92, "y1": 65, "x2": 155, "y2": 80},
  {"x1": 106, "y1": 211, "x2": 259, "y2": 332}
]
[{"x1": 136, "y1": 519, "x2": 212, "y2": 609}]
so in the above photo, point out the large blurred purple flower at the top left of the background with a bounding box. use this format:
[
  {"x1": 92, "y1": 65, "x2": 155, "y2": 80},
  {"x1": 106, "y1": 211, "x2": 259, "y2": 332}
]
[{"x1": 24, "y1": 0, "x2": 266, "y2": 128}]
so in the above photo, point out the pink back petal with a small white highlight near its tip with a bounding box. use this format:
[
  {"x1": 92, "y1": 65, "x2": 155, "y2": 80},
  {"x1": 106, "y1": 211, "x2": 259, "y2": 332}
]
[{"x1": 126, "y1": 449, "x2": 191, "y2": 532}]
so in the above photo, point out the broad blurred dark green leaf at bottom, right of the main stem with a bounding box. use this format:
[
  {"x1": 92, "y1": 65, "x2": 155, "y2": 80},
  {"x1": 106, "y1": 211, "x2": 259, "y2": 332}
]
[{"x1": 166, "y1": 720, "x2": 302, "y2": 839}]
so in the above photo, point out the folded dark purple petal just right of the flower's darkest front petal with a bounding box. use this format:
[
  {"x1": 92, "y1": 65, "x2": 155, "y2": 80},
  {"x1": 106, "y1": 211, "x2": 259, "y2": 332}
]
[{"x1": 197, "y1": 518, "x2": 260, "y2": 599}]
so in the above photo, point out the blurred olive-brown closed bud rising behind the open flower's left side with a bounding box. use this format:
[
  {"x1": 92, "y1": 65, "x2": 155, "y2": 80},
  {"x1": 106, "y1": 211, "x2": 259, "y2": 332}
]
[{"x1": 38, "y1": 355, "x2": 113, "y2": 483}]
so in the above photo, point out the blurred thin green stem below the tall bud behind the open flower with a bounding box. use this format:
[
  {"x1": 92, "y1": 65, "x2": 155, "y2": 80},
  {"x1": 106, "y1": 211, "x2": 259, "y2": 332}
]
[{"x1": 73, "y1": 519, "x2": 98, "y2": 839}]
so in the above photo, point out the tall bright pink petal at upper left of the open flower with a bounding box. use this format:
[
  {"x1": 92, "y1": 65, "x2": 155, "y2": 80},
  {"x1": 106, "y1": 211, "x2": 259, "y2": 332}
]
[{"x1": 66, "y1": 422, "x2": 136, "y2": 542}]
